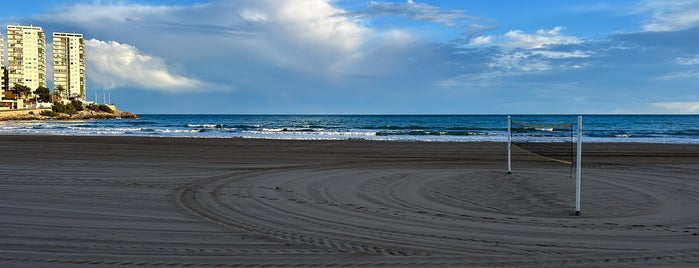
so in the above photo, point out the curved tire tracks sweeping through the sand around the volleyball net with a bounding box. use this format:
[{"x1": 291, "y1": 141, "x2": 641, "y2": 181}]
[{"x1": 177, "y1": 163, "x2": 699, "y2": 264}]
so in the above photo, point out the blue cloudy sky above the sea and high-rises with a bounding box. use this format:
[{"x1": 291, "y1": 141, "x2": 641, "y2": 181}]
[{"x1": 0, "y1": 0, "x2": 699, "y2": 114}]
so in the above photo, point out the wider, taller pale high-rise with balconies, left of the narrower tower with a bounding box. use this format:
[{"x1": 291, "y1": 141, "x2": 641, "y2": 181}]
[{"x1": 6, "y1": 25, "x2": 46, "y2": 96}]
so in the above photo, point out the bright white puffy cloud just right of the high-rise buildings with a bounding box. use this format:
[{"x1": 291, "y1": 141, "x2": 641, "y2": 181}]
[{"x1": 85, "y1": 39, "x2": 204, "y2": 92}]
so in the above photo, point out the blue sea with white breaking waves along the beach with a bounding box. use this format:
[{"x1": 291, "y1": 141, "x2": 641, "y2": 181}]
[{"x1": 0, "y1": 114, "x2": 699, "y2": 144}]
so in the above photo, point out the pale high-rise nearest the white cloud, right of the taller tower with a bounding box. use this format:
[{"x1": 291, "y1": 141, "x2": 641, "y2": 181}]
[{"x1": 53, "y1": 33, "x2": 85, "y2": 101}]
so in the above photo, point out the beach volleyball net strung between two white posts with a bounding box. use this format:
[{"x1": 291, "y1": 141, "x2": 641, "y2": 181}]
[{"x1": 507, "y1": 116, "x2": 582, "y2": 215}]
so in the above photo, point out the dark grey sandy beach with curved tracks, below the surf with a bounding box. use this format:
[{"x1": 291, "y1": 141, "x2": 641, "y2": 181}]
[{"x1": 0, "y1": 136, "x2": 699, "y2": 267}]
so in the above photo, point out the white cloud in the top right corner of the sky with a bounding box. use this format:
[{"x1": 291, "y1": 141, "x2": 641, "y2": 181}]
[{"x1": 636, "y1": 0, "x2": 699, "y2": 32}]
